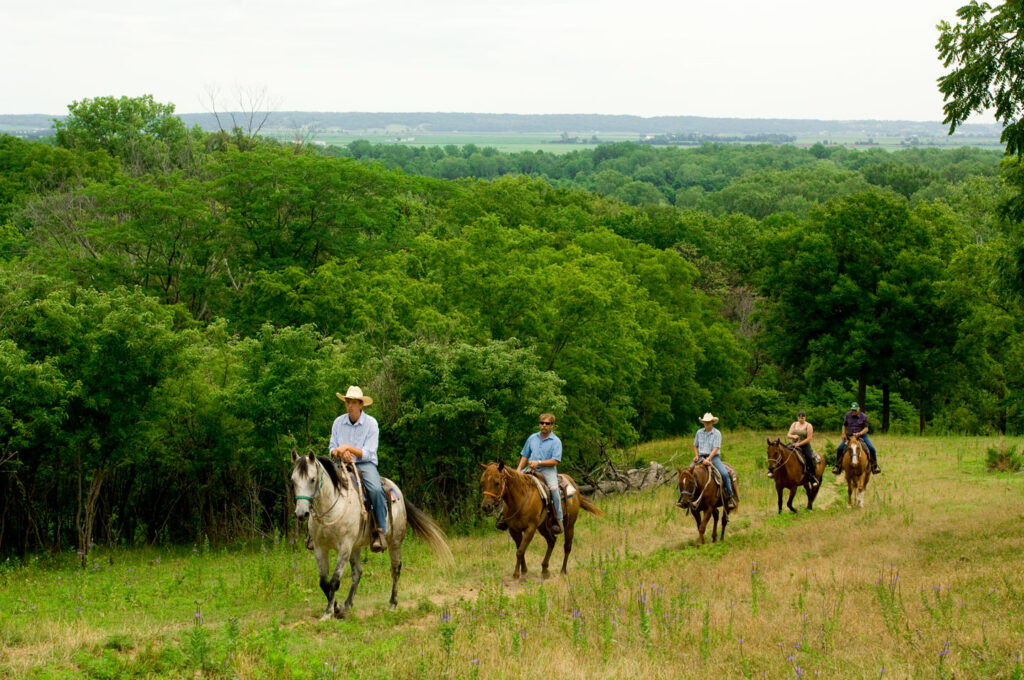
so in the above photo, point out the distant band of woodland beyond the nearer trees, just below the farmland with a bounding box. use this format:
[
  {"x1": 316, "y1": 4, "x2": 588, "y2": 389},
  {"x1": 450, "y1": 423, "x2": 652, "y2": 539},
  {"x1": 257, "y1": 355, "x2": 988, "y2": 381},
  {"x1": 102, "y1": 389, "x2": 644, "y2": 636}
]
[{"x1": 322, "y1": 135, "x2": 1001, "y2": 219}]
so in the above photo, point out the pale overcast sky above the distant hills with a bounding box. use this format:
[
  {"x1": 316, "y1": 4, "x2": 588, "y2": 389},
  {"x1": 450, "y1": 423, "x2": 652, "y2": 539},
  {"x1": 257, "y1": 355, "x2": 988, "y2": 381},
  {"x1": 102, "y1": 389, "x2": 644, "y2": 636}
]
[{"x1": 0, "y1": 0, "x2": 991, "y2": 122}]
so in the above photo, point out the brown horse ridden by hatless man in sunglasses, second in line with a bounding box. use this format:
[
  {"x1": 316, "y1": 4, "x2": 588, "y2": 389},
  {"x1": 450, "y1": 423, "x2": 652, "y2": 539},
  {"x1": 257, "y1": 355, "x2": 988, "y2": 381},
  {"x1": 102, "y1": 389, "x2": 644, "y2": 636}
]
[{"x1": 480, "y1": 461, "x2": 604, "y2": 579}]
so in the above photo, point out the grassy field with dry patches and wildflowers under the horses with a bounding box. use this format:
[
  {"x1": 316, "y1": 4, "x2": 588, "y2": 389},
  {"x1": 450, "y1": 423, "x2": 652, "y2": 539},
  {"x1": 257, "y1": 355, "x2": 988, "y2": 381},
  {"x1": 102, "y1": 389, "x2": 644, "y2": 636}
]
[{"x1": 0, "y1": 432, "x2": 1024, "y2": 679}]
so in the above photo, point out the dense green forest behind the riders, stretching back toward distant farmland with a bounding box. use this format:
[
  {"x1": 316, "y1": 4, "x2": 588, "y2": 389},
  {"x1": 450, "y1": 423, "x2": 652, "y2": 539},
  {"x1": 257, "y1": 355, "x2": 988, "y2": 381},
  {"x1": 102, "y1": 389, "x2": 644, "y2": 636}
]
[{"x1": 0, "y1": 97, "x2": 1024, "y2": 554}]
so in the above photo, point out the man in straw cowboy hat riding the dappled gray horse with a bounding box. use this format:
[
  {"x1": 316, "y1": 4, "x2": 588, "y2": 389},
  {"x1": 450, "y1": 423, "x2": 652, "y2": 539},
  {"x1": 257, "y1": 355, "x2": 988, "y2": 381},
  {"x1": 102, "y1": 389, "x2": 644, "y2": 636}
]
[{"x1": 331, "y1": 385, "x2": 387, "y2": 552}]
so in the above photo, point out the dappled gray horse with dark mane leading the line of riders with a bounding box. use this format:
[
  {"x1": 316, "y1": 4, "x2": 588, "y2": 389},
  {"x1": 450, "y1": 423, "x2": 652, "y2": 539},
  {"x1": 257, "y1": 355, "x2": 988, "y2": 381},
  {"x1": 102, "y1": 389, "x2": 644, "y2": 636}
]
[{"x1": 292, "y1": 451, "x2": 455, "y2": 621}]
